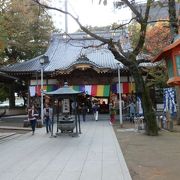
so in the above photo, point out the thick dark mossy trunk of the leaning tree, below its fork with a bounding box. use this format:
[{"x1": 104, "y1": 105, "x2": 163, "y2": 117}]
[{"x1": 130, "y1": 65, "x2": 158, "y2": 136}]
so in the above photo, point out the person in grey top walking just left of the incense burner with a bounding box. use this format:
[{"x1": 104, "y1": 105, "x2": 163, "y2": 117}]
[{"x1": 43, "y1": 103, "x2": 53, "y2": 133}]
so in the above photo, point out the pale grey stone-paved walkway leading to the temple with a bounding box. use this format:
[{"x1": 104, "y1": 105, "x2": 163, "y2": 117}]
[{"x1": 0, "y1": 115, "x2": 131, "y2": 180}]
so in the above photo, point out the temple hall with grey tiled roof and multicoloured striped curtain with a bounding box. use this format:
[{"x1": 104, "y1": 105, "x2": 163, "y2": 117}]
[{"x1": 2, "y1": 31, "x2": 142, "y2": 112}]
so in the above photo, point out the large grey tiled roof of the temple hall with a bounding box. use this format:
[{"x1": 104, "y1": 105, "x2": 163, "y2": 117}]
[{"x1": 3, "y1": 32, "x2": 127, "y2": 73}]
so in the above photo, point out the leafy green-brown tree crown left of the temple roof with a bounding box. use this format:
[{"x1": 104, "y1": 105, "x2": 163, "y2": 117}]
[{"x1": 0, "y1": 0, "x2": 54, "y2": 65}]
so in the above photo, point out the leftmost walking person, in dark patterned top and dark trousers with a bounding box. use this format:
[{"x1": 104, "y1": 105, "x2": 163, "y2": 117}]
[{"x1": 28, "y1": 105, "x2": 39, "y2": 135}]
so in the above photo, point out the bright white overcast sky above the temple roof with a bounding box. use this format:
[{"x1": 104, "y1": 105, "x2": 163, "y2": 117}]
[{"x1": 51, "y1": 0, "x2": 131, "y2": 32}]
